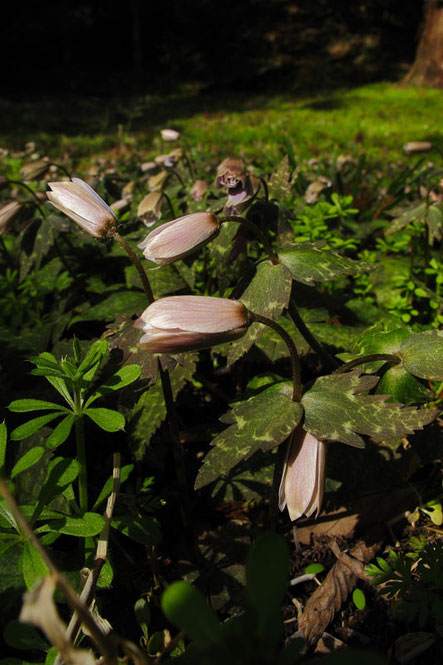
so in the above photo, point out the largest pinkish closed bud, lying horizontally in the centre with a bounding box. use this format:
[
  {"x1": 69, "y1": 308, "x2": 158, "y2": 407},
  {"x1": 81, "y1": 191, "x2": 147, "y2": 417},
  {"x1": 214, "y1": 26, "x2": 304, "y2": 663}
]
[{"x1": 134, "y1": 296, "x2": 249, "y2": 353}]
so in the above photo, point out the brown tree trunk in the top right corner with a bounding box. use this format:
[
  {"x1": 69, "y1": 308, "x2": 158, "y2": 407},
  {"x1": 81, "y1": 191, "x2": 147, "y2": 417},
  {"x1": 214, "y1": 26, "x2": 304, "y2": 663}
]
[{"x1": 403, "y1": 0, "x2": 443, "y2": 88}]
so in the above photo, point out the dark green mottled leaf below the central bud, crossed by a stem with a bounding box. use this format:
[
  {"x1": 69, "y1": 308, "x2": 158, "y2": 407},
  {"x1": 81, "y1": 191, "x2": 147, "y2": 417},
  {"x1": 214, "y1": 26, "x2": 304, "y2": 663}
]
[{"x1": 128, "y1": 353, "x2": 198, "y2": 460}]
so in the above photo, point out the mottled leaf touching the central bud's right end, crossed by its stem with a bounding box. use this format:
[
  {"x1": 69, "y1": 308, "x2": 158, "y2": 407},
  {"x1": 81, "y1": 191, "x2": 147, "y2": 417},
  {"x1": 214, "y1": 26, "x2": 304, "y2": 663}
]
[{"x1": 227, "y1": 261, "x2": 292, "y2": 365}]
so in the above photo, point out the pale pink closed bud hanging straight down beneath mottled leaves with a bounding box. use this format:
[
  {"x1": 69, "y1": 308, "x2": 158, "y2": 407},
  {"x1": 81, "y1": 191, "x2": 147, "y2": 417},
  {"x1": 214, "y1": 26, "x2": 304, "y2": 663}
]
[{"x1": 278, "y1": 425, "x2": 326, "y2": 520}]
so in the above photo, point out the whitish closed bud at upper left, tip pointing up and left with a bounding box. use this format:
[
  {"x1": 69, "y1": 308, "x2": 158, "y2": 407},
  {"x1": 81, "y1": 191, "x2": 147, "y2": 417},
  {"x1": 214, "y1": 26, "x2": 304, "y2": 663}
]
[{"x1": 47, "y1": 178, "x2": 117, "y2": 238}]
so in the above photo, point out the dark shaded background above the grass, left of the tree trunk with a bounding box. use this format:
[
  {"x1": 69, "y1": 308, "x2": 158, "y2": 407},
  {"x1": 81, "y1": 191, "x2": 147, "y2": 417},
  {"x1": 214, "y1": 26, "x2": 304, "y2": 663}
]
[{"x1": 0, "y1": 0, "x2": 424, "y2": 98}]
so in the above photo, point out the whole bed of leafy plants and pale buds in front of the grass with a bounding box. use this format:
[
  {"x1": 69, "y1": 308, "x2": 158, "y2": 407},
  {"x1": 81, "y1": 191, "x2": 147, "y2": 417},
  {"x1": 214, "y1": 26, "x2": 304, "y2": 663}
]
[{"x1": 0, "y1": 86, "x2": 443, "y2": 664}]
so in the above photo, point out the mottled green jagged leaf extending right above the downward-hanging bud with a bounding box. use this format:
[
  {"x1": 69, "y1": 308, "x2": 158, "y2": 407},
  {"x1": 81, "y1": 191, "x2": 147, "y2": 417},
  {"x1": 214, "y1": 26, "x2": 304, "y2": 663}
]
[{"x1": 302, "y1": 371, "x2": 438, "y2": 448}]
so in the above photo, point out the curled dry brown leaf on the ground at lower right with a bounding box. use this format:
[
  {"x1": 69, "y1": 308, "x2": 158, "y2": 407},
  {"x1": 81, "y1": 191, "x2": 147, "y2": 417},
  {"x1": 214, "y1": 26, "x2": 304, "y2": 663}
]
[{"x1": 298, "y1": 535, "x2": 383, "y2": 643}]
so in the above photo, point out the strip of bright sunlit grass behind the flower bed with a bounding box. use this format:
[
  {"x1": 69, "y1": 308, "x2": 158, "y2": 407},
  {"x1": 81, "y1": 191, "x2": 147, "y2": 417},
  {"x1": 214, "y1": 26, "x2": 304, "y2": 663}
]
[{"x1": 0, "y1": 83, "x2": 443, "y2": 168}]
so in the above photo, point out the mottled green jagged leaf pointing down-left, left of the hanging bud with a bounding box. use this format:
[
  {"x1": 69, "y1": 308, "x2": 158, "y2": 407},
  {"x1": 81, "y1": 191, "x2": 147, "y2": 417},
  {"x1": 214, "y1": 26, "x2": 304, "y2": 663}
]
[{"x1": 195, "y1": 392, "x2": 303, "y2": 489}]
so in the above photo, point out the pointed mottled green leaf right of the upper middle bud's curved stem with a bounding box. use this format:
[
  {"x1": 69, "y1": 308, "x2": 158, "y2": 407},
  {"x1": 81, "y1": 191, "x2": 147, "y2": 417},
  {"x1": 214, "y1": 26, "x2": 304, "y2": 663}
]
[{"x1": 278, "y1": 241, "x2": 377, "y2": 285}]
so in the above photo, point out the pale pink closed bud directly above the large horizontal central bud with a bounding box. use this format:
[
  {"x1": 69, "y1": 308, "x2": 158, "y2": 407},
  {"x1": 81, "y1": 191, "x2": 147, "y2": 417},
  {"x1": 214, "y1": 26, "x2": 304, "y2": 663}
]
[{"x1": 138, "y1": 212, "x2": 219, "y2": 266}]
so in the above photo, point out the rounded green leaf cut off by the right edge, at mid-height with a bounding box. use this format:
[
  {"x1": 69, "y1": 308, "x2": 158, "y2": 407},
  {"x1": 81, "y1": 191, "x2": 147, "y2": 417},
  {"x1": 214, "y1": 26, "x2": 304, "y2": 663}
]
[{"x1": 400, "y1": 330, "x2": 443, "y2": 381}]
